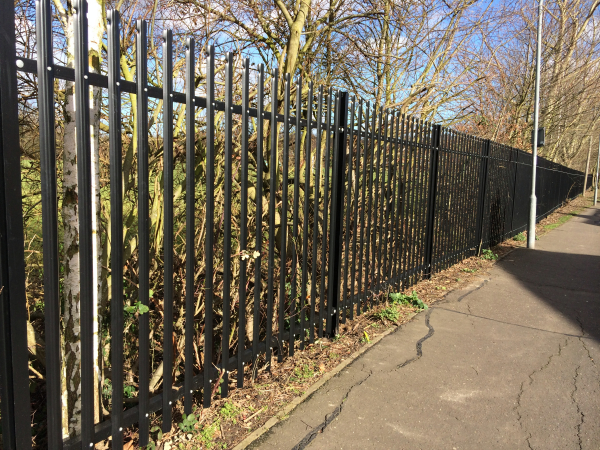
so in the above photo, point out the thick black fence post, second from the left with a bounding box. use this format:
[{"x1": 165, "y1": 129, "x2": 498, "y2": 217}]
[{"x1": 326, "y1": 92, "x2": 348, "y2": 336}]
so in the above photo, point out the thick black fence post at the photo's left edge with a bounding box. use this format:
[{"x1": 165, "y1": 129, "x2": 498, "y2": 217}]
[{"x1": 0, "y1": 2, "x2": 31, "y2": 449}]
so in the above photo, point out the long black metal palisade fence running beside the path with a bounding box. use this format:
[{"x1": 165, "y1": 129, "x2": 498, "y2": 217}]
[{"x1": 0, "y1": 4, "x2": 583, "y2": 449}]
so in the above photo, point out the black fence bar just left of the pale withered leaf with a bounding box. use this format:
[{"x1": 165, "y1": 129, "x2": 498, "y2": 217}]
[{"x1": 237, "y1": 58, "x2": 250, "y2": 388}]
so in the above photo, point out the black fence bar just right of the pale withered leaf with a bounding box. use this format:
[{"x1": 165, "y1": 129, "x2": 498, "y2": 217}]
[{"x1": 252, "y1": 64, "x2": 265, "y2": 362}]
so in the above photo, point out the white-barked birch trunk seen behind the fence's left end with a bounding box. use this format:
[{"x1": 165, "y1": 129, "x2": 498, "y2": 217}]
[{"x1": 62, "y1": 0, "x2": 106, "y2": 437}]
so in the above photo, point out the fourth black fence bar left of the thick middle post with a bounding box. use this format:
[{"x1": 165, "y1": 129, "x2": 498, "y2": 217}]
[{"x1": 289, "y1": 75, "x2": 300, "y2": 356}]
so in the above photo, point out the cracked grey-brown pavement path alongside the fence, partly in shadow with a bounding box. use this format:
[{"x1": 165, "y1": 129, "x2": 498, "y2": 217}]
[{"x1": 250, "y1": 208, "x2": 600, "y2": 450}]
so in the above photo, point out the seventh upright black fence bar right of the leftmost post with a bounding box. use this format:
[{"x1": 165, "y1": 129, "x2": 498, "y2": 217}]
[{"x1": 204, "y1": 45, "x2": 215, "y2": 408}]
